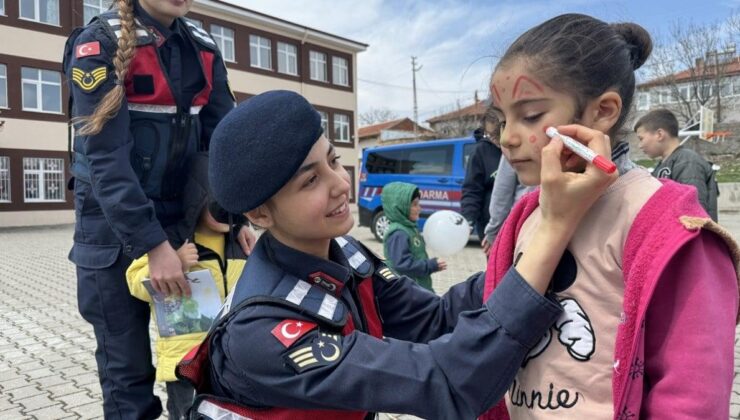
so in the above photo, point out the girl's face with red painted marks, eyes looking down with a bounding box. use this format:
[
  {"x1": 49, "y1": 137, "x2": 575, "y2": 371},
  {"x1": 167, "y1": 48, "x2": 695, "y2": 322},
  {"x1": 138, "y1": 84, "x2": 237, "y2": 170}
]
[{"x1": 491, "y1": 59, "x2": 588, "y2": 185}]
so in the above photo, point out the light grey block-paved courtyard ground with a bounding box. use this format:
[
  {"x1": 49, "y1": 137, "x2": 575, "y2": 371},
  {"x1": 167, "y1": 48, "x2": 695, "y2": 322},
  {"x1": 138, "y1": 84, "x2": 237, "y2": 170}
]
[{"x1": 0, "y1": 213, "x2": 740, "y2": 420}]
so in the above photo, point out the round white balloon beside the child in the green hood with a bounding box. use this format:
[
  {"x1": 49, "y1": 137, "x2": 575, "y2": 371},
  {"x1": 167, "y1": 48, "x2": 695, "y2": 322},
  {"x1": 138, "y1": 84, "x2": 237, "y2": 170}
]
[{"x1": 422, "y1": 210, "x2": 470, "y2": 257}]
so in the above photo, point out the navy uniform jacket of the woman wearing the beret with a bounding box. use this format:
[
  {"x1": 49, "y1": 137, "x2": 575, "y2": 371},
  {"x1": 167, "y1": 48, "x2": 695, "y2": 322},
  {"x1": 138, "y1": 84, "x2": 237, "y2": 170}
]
[{"x1": 209, "y1": 234, "x2": 560, "y2": 419}]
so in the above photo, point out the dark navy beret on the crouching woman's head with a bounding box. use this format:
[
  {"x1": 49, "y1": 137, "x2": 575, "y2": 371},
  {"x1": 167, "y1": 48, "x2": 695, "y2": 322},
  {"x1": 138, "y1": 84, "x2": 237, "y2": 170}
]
[{"x1": 209, "y1": 90, "x2": 324, "y2": 213}]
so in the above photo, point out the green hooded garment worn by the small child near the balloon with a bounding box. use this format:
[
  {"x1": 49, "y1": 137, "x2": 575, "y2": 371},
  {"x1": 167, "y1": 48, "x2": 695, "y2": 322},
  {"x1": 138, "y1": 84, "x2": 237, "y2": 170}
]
[{"x1": 381, "y1": 182, "x2": 437, "y2": 291}]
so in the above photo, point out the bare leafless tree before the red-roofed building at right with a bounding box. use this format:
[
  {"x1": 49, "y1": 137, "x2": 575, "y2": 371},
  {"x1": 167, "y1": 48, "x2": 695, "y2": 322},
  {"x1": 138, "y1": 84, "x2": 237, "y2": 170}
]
[{"x1": 646, "y1": 15, "x2": 738, "y2": 121}]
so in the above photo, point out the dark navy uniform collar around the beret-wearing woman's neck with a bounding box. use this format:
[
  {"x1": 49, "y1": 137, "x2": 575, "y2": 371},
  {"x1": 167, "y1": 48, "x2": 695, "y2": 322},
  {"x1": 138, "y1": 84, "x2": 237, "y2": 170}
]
[{"x1": 263, "y1": 233, "x2": 352, "y2": 296}]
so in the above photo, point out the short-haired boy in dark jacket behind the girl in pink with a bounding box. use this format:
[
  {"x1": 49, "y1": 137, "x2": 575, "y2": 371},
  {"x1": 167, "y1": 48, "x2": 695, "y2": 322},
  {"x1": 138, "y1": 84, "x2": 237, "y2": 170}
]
[{"x1": 635, "y1": 109, "x2": 719, "y2": 222}]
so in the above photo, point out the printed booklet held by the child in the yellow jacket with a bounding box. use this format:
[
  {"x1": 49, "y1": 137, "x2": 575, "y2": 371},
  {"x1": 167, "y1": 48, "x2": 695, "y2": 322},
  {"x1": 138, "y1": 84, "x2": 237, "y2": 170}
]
[{"x1": 142, "y1": 270, "x2": 222, "y2": 337}]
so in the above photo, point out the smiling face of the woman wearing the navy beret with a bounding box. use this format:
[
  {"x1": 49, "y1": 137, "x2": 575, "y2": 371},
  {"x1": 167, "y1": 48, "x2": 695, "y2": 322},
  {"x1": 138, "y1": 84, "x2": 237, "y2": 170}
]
[{"x1": 248, "y1": 136, "x2": 354, "y2": 257}]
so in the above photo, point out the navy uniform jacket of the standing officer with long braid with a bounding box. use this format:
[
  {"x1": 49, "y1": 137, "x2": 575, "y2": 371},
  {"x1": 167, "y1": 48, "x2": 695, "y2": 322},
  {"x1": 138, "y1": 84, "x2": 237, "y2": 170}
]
[{"x1": 64, "y1": 3, "x2": 234, "y2": 260}]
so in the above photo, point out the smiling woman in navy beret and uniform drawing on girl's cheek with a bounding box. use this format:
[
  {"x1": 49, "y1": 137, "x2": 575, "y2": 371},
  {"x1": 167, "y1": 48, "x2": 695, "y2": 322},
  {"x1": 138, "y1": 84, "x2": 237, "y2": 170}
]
[{"x1": 178, "y1": 91, "x2": 616, "y2": 419}]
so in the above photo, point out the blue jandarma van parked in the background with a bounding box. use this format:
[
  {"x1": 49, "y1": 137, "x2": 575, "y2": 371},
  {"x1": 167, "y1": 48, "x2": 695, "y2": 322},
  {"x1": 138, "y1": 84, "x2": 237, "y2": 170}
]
[{"x1": 357, "y1": 137, "x2": 475, "y2": 241}]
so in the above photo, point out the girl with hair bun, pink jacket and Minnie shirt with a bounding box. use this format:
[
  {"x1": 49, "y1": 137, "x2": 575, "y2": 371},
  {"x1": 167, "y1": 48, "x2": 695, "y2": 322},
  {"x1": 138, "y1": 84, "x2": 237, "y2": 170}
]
[{"x1": 476, "y1": 14, "x2": 738, "y2": 419}]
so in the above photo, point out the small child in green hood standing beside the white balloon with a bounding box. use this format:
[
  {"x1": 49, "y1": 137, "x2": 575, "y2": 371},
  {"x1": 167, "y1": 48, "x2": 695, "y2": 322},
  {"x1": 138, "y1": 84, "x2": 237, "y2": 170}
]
[{"x1": 381, "y1": 182, "x2": 447, "y2": 292}]
